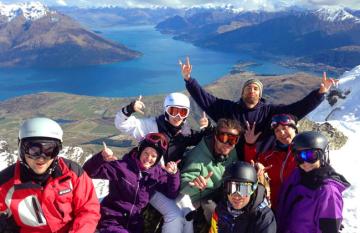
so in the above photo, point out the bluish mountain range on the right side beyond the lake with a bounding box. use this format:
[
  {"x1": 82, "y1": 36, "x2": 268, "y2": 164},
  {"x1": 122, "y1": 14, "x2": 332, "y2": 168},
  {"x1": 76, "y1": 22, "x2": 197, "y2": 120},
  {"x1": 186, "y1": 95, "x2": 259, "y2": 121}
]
[{"x1": 156, "y1": 8, "x2": 360, "y2": 69}]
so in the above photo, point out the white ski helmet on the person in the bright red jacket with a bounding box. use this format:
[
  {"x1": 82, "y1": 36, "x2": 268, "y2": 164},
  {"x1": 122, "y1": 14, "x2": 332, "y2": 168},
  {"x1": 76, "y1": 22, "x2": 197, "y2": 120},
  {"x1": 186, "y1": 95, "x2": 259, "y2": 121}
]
[{"x1": 19, "y1": 117, "x2": 63, "y2": 142}]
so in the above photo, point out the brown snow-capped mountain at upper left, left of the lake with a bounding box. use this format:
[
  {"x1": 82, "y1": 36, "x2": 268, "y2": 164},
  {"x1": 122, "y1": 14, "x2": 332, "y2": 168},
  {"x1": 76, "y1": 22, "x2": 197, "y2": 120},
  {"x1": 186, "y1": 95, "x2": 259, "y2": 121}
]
[{"x1": 0, "y1": 2, "x2": 141, "y2": 67}]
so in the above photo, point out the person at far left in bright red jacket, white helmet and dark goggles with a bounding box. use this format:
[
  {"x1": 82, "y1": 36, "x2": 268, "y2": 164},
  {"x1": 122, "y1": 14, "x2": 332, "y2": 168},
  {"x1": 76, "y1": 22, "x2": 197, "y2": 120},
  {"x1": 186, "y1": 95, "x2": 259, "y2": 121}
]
[{"x1": 0, "y1": 118, "x2": 100, "y2": 233}]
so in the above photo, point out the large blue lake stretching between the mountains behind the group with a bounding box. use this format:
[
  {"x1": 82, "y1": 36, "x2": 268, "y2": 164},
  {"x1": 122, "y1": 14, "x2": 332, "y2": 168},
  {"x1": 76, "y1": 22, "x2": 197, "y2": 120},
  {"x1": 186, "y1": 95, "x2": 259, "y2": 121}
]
[{"x1": 0, "y1": 26, "x2": 294, "y2": 100}]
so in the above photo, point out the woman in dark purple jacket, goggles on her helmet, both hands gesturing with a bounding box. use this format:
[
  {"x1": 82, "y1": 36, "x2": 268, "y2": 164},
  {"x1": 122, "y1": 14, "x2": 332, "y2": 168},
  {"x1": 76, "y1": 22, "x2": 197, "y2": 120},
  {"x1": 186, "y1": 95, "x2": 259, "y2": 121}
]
[{"x1": 83, "y1": 133, "x2": 180, "y2": 233}]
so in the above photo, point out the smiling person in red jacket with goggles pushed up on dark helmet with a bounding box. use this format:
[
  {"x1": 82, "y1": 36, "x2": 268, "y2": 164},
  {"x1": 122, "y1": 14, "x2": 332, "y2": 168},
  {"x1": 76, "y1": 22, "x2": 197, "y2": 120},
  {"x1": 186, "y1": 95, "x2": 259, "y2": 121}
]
[{"x1": 245, "y1": 114, "x2": 298, "y2": 210}]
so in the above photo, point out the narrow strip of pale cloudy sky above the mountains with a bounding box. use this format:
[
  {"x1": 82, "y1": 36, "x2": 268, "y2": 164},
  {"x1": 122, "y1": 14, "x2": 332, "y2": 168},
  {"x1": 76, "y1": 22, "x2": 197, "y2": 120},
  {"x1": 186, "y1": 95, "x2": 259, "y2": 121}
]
[{"x1": 0, "y1": 0, "x2": 360, "y2": 11}]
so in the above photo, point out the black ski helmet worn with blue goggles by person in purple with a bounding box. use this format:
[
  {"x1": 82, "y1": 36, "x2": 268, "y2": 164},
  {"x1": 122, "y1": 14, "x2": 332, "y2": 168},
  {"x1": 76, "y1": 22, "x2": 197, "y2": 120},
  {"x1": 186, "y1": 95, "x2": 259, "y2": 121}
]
[{"x1": 291, "y1": 131, "x2": 330, "y2": 165}]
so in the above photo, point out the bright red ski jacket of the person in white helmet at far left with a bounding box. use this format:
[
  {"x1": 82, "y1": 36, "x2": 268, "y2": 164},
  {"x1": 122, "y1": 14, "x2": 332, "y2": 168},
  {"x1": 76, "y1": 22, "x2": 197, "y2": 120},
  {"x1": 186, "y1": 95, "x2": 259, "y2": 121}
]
[{"x1": 0, "y1": 158, "x2": 100, "y2": 233}]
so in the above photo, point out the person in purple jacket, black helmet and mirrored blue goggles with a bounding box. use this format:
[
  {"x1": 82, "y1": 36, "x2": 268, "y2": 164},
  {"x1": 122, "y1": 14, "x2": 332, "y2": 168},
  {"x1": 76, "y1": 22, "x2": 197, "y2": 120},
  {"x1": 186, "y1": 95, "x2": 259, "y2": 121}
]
[{"x1": 276, "y1": 131, "x2": 350, "y2": 233}]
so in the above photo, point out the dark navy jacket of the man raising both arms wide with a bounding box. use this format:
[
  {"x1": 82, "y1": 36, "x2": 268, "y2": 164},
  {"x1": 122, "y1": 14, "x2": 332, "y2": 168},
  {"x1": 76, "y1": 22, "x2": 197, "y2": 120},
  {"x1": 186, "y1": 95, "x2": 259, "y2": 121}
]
[{"x1": 186, "y1": 78, "x2": 324, "y2": 155}]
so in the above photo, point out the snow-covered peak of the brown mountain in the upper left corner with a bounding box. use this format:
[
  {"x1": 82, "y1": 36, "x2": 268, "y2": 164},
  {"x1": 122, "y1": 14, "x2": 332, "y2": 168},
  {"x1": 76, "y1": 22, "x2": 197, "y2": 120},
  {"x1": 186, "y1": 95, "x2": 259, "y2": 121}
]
[{"x1": 0, "y1": 2, "x2": 51, "y2": 21}]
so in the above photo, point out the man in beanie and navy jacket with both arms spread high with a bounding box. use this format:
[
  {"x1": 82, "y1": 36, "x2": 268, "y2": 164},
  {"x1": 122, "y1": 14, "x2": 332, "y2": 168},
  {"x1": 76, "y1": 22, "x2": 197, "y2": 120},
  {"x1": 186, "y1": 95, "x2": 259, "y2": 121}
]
[{"x1": 179, "y1": 58, "x2": 336, "y2": 155}]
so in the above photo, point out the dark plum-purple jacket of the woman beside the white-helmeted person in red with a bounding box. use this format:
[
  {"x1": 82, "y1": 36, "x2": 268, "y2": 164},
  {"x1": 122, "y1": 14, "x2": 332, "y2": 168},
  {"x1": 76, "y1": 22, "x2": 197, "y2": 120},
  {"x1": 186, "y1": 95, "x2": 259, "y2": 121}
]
[{"x1": 83, "y1": 150, "x2": 180, "y2": 232}]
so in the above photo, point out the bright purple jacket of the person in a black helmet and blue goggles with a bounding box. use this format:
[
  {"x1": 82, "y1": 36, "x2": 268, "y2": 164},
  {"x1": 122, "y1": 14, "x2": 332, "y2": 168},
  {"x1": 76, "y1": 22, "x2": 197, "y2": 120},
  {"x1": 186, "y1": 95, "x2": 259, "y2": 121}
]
[{"x1": 276, "y1": 168, "x2": 349, "y2": 233}]
